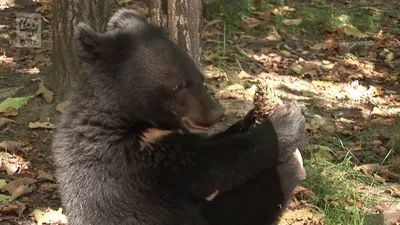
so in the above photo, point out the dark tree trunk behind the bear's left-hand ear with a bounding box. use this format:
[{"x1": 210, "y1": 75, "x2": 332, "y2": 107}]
[{"x1": 52, "y1": 0, "x2": 115, "y2": 96}]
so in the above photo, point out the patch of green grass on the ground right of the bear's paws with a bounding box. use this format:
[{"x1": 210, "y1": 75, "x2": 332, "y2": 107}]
[{"x1": 303, "y1": 131, "x2": 393, "y2": 225}]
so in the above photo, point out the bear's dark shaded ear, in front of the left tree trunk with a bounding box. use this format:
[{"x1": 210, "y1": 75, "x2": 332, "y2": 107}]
[{"x1": 75, "y1": 22, "x2": 109, "y2": 63}]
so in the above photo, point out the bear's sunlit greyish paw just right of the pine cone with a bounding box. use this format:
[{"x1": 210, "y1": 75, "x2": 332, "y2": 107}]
[{"x1": 269, "y1": 103, "x2": 306, "y2": 162}]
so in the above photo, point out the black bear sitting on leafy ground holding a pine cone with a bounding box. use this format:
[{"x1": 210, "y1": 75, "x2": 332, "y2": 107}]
[{"x1": 53, "y1": 10, "x2": 305, "y2": 225}]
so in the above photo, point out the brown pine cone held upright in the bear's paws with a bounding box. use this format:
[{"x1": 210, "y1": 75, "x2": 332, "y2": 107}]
[{"x1": 253, "y1": 81, "x2": 283, "y2": 124}]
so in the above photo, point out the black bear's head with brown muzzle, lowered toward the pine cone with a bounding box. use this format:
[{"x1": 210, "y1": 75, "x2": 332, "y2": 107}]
[{"x1": 75, "y1": 9, "x2": 224, "y2": 132}]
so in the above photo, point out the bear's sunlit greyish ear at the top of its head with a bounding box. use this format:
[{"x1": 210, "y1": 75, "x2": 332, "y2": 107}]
[{"x1": 107, "y1": 9, "x2": 148, "y2": 31}]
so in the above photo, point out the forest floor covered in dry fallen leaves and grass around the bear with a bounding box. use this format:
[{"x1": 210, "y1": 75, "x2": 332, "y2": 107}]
[{"x1": 0, "y1": 0, "x2": 400, "y2": 225}]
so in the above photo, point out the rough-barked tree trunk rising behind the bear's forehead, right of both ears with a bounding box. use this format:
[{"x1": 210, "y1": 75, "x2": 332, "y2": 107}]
[{"x1": 149, "y1": 0, "x2": 203, "y2": 68}]
